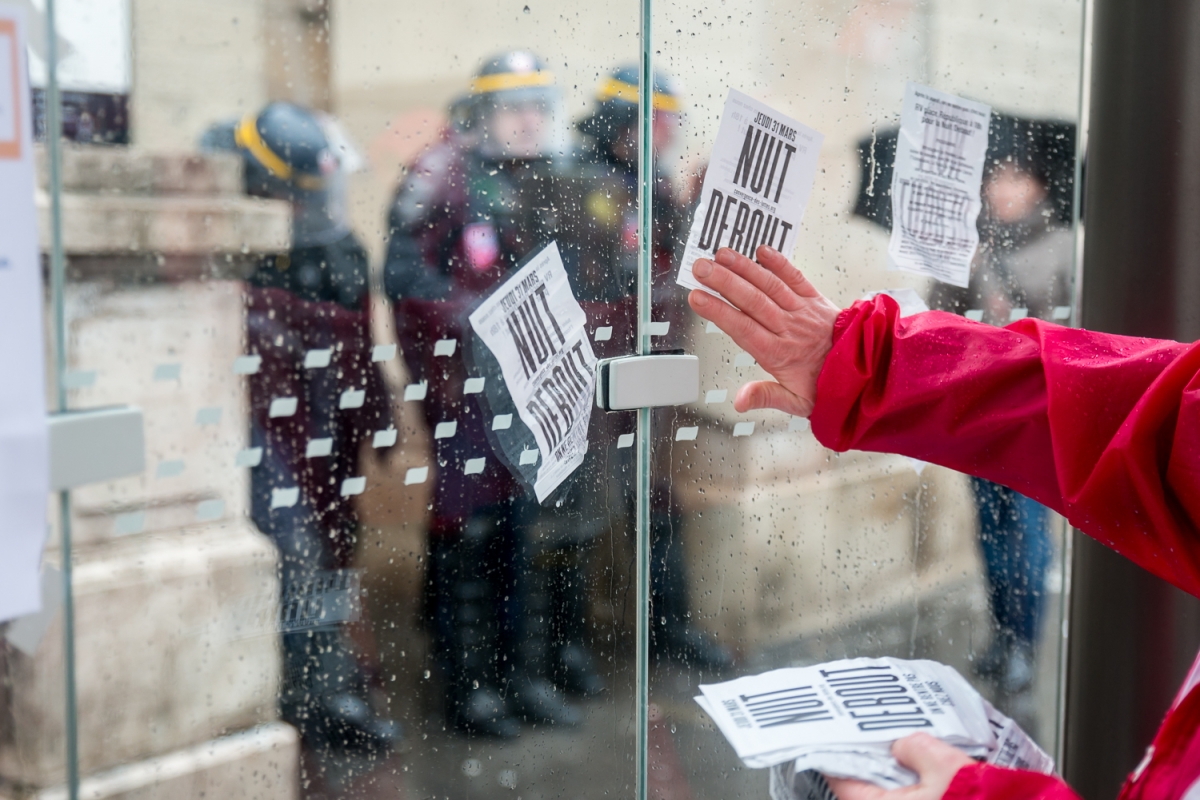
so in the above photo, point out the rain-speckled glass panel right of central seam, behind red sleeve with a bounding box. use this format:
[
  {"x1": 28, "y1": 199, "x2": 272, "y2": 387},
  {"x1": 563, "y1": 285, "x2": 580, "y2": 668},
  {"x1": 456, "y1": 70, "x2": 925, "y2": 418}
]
[{"x1": 650, "y1": 0, "x2": 1081, "y2": 799}]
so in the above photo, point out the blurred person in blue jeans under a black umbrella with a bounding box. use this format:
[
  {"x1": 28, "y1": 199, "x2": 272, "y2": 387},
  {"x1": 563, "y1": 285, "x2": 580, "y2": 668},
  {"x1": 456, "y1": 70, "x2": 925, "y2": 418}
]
[{"x1": 929, "y1": 115, "x2": 1074, "y2": 694}]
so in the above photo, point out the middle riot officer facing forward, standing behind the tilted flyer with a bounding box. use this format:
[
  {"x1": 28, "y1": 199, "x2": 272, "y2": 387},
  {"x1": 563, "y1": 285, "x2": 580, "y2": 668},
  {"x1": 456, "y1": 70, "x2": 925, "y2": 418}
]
[{"x1": 384, "y1": 50, "x2": 589, "y2": 738}]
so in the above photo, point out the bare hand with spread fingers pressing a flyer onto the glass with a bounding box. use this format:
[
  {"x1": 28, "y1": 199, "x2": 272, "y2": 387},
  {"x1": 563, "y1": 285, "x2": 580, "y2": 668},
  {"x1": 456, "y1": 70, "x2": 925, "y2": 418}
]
[{"x1": 688, "y1": 246, "x2": 841, "y2": 416}]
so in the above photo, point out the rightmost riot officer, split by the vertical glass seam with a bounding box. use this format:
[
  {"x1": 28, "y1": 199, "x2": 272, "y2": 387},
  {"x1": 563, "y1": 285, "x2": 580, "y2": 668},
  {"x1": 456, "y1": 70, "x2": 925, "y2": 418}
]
[{"x1": 564, "y1": 65, "x2": 732, "y2": 670}]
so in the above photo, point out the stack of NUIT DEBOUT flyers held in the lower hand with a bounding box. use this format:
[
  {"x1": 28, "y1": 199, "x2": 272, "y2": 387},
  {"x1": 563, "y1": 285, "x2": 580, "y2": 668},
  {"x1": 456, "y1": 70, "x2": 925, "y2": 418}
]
[{"x1": 696, "y1": 658, "x2": 1054, "y2": 800}]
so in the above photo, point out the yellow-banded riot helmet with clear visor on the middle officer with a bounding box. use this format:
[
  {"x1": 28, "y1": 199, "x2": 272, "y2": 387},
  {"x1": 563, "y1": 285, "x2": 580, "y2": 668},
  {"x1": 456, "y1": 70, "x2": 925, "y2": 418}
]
[{"x1": 465, "y1": 50, "x2": 565, "y2": 160}]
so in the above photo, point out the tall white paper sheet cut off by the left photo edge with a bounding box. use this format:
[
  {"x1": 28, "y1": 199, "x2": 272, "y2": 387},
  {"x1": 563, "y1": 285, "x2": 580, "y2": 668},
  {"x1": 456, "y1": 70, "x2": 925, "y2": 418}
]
[{"x1": 0, "y1": 2, "x2": 50, "y2": 621}]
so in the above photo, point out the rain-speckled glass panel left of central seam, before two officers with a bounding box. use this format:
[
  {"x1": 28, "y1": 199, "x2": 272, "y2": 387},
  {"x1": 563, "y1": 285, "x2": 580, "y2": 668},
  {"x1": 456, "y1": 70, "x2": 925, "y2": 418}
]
[{"x1": 9, "y1": 0, "x2": 638, "y2": 798}]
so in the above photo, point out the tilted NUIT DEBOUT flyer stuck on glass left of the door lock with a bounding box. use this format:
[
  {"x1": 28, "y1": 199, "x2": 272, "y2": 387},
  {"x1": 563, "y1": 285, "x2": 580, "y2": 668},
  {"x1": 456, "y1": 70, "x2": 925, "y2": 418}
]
[{"x1": 470, "y1": 242, "x2": 596, "y2": 503}]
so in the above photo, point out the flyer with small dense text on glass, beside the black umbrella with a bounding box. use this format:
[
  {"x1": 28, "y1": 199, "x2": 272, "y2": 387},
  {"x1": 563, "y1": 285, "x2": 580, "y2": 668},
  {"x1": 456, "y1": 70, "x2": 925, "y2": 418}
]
[{"x1": 888, "y1": 82, "x2": 991, "y2": 287}]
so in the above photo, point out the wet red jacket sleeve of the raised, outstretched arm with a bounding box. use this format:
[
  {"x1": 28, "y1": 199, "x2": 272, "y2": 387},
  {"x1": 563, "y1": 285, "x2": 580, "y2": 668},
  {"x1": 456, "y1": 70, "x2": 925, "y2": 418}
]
[{"x1": 811, "y1": 295, "x2": 1200, "y2": 595}]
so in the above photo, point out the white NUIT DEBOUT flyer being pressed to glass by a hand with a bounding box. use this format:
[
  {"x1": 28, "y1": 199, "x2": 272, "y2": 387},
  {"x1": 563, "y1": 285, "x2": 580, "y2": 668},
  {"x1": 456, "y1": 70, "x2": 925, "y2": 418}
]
[{"x1": 677, "y1": 89, "x2": 824, "y2": 291}]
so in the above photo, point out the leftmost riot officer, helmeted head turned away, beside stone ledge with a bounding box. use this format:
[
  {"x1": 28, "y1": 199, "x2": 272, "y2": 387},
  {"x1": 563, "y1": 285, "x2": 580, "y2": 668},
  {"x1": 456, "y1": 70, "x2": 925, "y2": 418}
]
[{"x1": 200, "y1": 103, "x2": 401, "y2": 754}]
